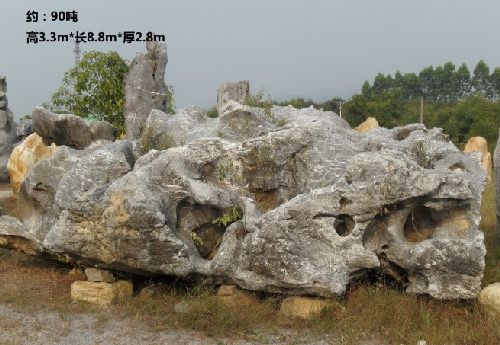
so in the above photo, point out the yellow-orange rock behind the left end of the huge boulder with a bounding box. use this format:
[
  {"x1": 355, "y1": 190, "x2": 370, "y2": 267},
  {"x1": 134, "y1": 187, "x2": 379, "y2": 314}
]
[{"x1": 7, "y1": 133, "x2": 56, "y2": 193}]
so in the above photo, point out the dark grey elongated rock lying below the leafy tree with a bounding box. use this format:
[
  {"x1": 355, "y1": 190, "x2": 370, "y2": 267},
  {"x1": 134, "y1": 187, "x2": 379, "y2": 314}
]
[{"x1": 33, "y1": 107, "x2": 118, "y2": 149}]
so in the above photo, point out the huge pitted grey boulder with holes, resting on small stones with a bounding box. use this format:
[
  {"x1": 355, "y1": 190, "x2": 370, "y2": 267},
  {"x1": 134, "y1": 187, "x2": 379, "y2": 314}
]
[{"x1": 0, "y1": 101, "x2": 485, "y2": 299}]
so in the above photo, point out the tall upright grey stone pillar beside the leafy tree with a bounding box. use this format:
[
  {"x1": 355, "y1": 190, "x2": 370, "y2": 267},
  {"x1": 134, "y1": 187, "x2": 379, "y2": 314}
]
[{"x1": 125, "y1": 42, "x2": 168, "y2": 139}]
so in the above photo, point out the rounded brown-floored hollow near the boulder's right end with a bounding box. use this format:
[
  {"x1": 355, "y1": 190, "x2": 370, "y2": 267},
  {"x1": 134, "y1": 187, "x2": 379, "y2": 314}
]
[{"x1": 403, "y1": 205, "x2": 438, "y2": 242}]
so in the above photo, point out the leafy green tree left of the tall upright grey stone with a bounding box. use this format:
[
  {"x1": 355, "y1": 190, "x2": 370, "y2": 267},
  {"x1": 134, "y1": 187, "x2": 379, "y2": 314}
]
[{"x1": 51, "y1": 51, "x2": 128, "y2": 132}]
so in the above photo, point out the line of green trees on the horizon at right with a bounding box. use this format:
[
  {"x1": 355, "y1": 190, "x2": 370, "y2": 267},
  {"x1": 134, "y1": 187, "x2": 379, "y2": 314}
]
[{"x1": 273, "y1": 60, "x2": 500, "y2": 152}]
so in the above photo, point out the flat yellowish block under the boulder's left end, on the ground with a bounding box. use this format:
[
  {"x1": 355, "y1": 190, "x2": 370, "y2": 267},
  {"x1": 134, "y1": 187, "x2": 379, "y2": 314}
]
[{"x1": 71, "y1": 280, "x2": 134, "y2": 305}]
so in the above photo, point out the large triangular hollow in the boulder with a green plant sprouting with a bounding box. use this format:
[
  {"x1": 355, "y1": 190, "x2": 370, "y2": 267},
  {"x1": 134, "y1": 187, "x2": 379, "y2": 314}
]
[{"x1": 176, "y1": 200, "x2": 243, "y2": 260}]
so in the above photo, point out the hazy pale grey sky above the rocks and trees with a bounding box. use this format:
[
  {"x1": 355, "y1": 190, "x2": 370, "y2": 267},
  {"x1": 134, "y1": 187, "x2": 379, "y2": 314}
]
[{"x1": 0, "y1": 0, "x2": 500, "y2": 118}]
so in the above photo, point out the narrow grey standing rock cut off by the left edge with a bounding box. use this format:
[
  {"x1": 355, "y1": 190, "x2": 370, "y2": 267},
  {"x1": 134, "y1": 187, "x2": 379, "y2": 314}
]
[{"x1": 0, "y1": 75, "x2": 16, "y2": 183}]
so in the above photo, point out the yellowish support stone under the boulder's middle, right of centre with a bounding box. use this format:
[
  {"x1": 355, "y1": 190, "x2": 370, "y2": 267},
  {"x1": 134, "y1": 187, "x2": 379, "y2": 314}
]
[{"x1": 280, "y1": 296, "x2": 342, "y2": 319}]
